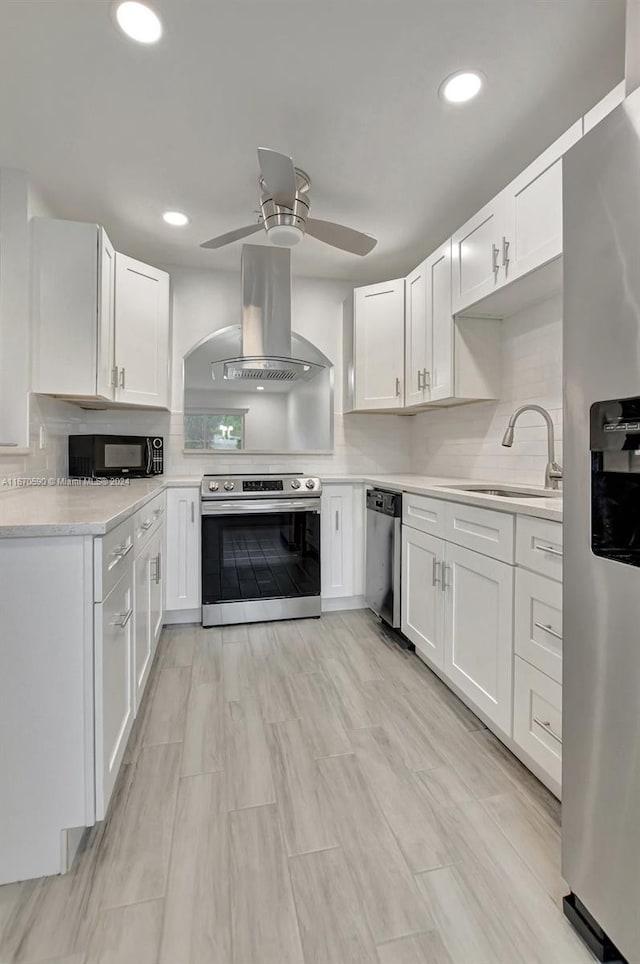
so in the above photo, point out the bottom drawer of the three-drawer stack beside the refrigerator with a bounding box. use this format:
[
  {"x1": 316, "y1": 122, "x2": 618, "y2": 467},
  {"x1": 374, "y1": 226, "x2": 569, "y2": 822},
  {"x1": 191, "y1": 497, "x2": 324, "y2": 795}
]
[{"x1": 513, "y1": 656, "x2": 562, "y2": 787}]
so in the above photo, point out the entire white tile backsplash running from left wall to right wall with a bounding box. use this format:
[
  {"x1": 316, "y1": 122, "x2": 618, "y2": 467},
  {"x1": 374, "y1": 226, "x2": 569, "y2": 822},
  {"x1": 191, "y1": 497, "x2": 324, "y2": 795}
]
[{"x1": 0, "y1": 297, "x2": 562, "y2": 491}]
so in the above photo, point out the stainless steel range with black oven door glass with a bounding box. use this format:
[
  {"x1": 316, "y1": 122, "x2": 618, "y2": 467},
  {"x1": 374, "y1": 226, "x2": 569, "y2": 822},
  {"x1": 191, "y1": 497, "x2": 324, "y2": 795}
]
[{"x1": 201, "y1": 472, "x2": 322, "y2": 626}]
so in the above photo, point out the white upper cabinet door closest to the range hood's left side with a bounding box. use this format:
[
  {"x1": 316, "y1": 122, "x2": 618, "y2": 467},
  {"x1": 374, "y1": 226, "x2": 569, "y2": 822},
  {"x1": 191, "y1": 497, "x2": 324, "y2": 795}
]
[{"x1": 115, "y1": 252, "x2": 169, "y2": 408}]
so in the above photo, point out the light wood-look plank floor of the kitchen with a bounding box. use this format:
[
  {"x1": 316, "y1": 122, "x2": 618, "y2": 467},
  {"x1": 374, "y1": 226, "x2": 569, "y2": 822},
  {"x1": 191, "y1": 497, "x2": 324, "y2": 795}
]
[{"x1": 0, "y1": 612, "x2": 592, "y2": 964}]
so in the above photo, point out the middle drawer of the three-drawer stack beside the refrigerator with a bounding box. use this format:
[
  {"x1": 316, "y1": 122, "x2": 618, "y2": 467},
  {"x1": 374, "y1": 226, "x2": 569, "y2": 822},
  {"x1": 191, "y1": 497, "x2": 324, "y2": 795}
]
[{"x1": 515, "y1": 569, "x2": 562, "y2": 683}]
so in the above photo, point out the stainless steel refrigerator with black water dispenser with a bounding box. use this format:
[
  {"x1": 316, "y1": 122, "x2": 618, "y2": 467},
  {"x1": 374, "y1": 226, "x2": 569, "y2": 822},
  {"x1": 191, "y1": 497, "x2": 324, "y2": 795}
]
[{"x1": 562, "y1": 91, "x2": 640, "y2": 964}]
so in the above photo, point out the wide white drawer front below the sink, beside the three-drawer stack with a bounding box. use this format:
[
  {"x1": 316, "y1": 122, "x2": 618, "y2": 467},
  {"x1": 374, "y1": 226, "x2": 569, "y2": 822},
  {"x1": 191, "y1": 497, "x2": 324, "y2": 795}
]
[{"x1": 445, "y1": 502, "x2": 515, "y2": 565}]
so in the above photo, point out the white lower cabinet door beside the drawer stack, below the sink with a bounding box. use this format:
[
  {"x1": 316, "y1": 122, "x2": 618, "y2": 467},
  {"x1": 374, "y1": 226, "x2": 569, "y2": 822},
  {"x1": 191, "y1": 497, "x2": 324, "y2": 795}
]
[{"x1": 443, "y1": 543, "x2": 513, "y2": 735}]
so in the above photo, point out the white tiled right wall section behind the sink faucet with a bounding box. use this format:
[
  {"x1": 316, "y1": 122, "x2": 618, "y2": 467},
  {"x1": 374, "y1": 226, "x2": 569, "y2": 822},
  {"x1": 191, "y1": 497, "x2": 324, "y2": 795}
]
[{"x1": 411, "y1": 296, "x2": 562, "y2": 485}]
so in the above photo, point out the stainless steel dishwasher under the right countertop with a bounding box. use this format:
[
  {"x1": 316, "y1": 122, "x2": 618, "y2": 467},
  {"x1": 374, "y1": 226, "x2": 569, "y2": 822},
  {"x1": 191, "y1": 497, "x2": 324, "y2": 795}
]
[{"x1": 365, "y1": 489, "x2": 402, "y2": 629}]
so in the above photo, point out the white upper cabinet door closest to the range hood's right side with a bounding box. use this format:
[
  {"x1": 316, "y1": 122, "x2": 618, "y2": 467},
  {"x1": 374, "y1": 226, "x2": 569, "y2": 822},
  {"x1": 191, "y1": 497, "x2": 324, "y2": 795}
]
[{"x1": 354, "y1": 278, "x2": 404, "y2": 409}]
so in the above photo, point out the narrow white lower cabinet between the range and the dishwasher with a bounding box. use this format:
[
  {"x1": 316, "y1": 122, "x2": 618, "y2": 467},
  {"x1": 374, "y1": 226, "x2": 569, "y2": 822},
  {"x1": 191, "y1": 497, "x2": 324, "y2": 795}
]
[{"x1": 320, "y1": 483, "x2": 364, "y2": 599}]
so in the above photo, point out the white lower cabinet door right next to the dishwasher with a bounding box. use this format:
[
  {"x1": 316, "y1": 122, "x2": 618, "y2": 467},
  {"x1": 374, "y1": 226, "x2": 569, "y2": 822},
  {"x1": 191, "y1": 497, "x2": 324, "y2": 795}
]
[{"x1": 402, "y1": 526, "x2": 445, "y2": 669}]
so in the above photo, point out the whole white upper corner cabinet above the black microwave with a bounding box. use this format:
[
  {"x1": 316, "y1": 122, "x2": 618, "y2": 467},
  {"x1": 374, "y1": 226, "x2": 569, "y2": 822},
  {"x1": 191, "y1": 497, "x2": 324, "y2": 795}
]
[{"x1": 32, "y1": 218, "x2": 169, "y2": 408}]
